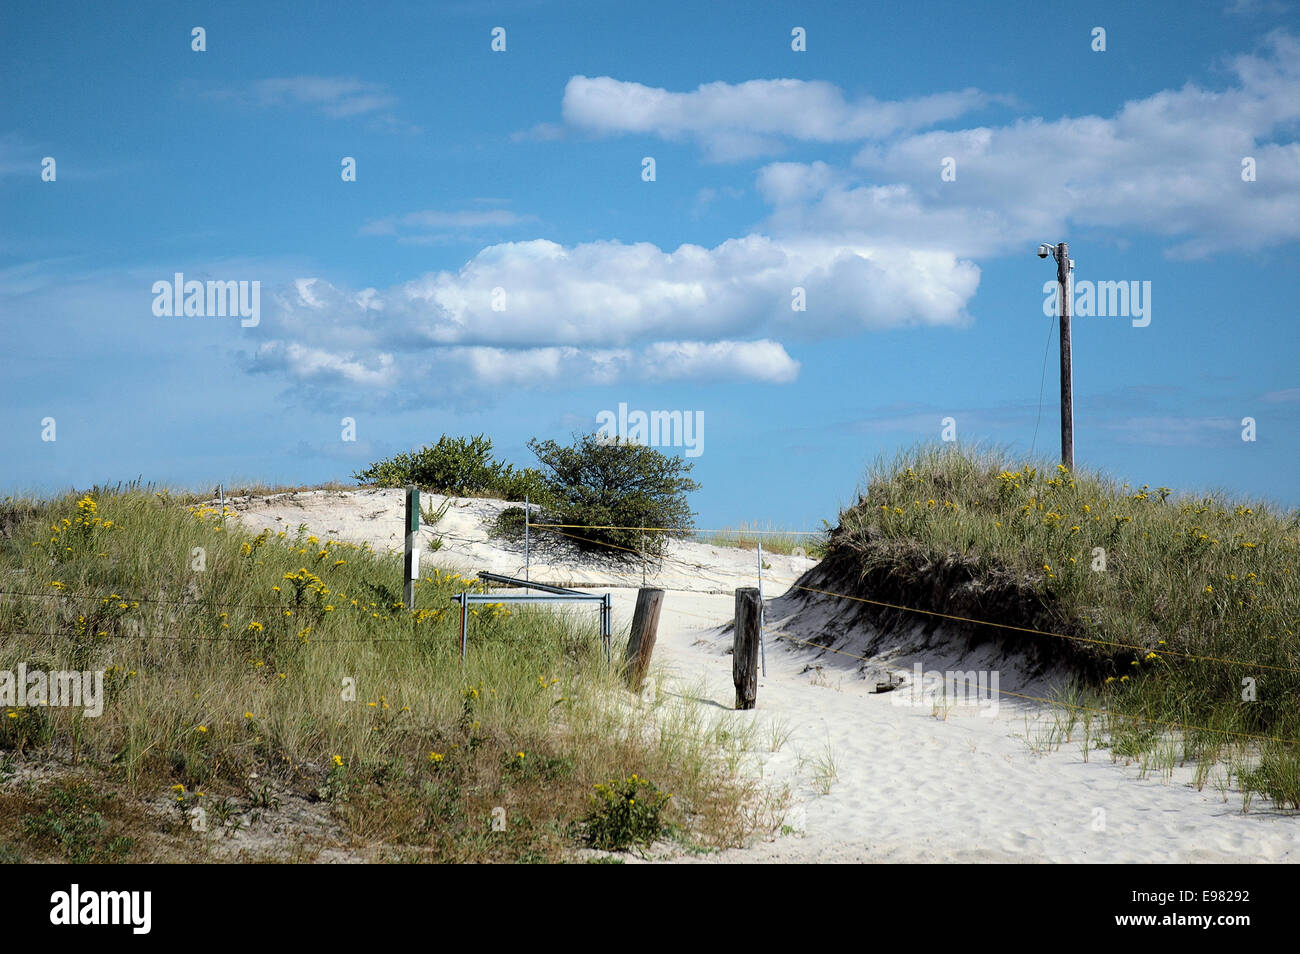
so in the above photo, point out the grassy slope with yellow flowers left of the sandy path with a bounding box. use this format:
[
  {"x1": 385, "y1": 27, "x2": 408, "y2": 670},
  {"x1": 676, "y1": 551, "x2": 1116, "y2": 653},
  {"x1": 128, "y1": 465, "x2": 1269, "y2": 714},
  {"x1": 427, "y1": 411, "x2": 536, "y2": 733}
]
[{"x1": 0, "y1": 487, "x2": 759, "y2": 860}]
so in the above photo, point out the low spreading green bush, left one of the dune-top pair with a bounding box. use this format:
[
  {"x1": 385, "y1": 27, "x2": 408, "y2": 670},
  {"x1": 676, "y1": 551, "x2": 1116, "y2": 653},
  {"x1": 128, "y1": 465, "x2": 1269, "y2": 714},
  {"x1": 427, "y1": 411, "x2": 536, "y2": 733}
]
[{"x1": 352, "y1": 434, "x2": 546, "y2": 500}]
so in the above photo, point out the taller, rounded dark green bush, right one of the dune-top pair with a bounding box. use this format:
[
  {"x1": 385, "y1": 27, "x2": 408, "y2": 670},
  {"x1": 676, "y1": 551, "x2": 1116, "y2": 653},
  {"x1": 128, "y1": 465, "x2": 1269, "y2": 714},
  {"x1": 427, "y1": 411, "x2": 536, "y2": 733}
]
[{"x1": 528, "y1": 434, "x2": 699, "y2": 559}]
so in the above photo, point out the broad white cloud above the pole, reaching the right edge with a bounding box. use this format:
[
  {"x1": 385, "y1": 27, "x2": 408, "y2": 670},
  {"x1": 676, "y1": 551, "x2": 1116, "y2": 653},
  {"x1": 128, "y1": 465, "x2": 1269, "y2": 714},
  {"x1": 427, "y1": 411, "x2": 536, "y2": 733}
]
[{"x1": 757, "y1": 32, "x2": 1300, "y2": 257}]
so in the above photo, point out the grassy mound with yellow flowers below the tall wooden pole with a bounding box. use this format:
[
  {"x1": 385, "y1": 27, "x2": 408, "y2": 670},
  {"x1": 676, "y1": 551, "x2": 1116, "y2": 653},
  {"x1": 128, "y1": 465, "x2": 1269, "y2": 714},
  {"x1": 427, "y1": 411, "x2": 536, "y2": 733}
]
[{"x1": 828, "y1": 447, "x2": 1300, "y2": 799}]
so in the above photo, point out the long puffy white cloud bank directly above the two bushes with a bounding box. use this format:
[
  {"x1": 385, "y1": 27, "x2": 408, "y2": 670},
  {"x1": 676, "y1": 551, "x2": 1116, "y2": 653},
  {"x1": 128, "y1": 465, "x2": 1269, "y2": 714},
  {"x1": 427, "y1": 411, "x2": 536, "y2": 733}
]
[{"x1": 256, "y1": 235, "x2": 979, "y2": 402}]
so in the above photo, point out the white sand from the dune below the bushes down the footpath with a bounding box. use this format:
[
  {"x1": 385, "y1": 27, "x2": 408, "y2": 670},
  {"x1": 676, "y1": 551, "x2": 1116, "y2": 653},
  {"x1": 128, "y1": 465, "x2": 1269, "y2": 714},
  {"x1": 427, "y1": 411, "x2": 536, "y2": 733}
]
[{"x1": 223, "y1": 490, "x2": 1300, "y2": 863}]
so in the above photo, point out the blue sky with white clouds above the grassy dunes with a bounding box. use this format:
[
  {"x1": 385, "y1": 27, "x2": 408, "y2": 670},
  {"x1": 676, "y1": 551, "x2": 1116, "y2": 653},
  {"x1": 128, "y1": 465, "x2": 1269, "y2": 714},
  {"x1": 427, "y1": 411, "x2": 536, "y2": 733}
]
[{"x1": 0, "y1": 0, "x2": 1300, "y2": 526}]
